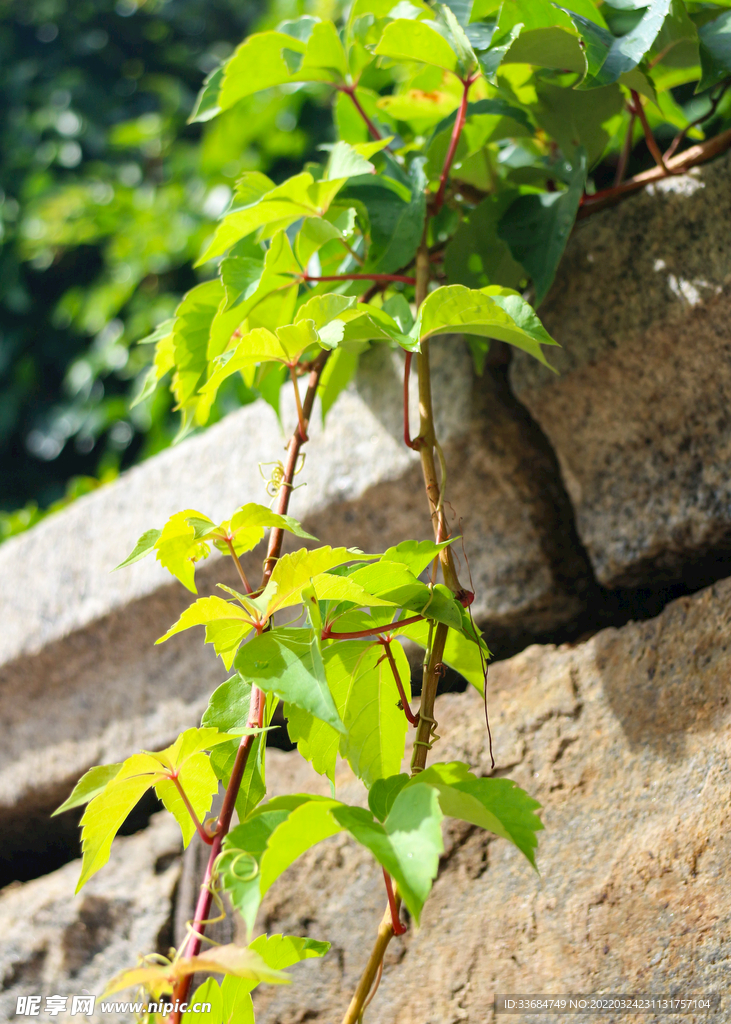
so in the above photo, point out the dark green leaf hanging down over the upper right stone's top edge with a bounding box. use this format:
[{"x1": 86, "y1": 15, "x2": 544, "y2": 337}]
[{"x1": 498, "y1": 147, "x2": 587, "y2": 303}]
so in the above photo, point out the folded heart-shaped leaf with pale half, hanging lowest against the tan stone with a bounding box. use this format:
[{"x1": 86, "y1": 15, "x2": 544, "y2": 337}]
[{"x1": 331, "y1": 784, "x2": 444, "y2": 924}]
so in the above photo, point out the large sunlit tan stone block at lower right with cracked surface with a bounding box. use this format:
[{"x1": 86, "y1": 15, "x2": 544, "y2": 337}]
[{"x1": 248, "y1": 581, "x2": 731, "y2": 1024}]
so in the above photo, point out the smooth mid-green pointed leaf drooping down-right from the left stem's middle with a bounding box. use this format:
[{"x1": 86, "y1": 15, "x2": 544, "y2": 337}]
[{"x1": 235, "y1": 629, "x2": 344, "y2": 731}]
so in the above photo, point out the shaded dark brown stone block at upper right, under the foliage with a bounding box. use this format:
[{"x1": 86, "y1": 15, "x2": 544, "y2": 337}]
[{"x1": 511, "y1": 149, "x2": 731, "y2": 587}]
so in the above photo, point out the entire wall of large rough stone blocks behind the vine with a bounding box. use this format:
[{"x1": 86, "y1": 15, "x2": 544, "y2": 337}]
[{"x1": 0, "y1": 158, "x2": 731, "y2": 1024}]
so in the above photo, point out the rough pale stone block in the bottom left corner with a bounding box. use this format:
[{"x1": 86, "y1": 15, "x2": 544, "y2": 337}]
[{"x1": 0, "y1": 813, "x2": 182, "y2": 1022}]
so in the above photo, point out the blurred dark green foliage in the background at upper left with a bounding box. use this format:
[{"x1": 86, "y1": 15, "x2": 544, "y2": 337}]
[{"x1": 0, "y1": 0, "x2": 330, "y2": 540}]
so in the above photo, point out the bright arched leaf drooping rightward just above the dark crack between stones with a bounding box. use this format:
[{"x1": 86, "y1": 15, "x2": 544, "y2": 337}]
[{"x1": 414, "y1": 284, "x2": 556, "y2": 366}]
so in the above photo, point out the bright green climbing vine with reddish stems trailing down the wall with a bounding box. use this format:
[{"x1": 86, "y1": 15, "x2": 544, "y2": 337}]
[{"x1": 59, "y1": 0, "x2": 731, "y2": 1024}]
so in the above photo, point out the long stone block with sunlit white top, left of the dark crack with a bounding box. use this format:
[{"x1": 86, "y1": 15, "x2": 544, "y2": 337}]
[{"x1": 0, "y1": 338, "x2": 589, "y2": 860}]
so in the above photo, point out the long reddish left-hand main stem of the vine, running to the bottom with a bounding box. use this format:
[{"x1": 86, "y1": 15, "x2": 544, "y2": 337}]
[{"x1": 170, "y1": 351, "x2": 330, "y2": 1024}]
